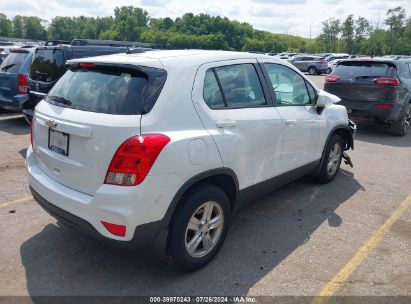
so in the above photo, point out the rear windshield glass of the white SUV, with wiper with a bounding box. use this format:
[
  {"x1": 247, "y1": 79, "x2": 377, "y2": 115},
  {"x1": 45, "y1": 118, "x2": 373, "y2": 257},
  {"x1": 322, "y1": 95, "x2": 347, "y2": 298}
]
[{"x1": 46, "y1": 67, "x2": 147, "y2": 115}]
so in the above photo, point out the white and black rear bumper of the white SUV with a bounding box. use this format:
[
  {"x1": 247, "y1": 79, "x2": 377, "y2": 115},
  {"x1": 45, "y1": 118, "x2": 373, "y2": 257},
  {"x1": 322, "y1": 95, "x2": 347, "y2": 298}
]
[{"x1": 26, "y1": 146, "x2": 182, "y2": 259}]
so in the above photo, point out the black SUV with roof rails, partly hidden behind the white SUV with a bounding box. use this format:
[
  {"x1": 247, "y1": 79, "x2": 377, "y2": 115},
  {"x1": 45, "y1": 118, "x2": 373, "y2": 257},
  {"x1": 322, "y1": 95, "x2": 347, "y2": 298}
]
[{"x1": 23, "y1": 39, "x2": 158, "y2": 121}]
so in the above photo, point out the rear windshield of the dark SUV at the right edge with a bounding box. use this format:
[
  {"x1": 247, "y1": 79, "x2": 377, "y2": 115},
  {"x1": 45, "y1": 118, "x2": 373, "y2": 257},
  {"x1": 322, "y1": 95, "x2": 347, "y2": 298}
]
[{"x1": 332, "y1": 61, "x2": 396, "y2": 79}]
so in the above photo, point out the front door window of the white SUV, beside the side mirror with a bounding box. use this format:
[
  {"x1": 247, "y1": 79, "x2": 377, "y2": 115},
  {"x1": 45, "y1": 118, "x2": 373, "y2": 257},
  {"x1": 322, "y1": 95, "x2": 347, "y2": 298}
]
[{"x1": 264, "y1": 63, "x2": 311, "y2": 106}]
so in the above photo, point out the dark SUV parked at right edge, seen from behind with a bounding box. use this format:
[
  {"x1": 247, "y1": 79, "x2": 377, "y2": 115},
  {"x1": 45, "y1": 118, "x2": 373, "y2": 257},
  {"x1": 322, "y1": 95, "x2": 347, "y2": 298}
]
[{"x1": 324, "y1": 58, "x2": 411, "y2": 136}]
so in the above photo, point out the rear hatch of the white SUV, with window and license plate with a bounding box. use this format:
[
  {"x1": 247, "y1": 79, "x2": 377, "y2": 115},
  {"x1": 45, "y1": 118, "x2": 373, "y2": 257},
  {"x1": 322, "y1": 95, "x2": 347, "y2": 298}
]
[{"x1": 33, "y1": 64, "x2": 167, "y2": 195}]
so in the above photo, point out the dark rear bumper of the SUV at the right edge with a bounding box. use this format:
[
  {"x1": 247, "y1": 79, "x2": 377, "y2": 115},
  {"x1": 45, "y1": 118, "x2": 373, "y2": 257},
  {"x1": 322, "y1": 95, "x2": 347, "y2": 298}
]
[{"x1": 339, "y1": 99, "x2": 402, "y2": 123}]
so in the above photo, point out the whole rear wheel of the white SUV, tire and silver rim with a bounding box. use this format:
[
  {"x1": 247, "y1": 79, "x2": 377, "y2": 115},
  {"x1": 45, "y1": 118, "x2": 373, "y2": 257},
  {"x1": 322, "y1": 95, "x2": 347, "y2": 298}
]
[{"x1": 168, "y1": 184, "x2": 230, "y2": 271}]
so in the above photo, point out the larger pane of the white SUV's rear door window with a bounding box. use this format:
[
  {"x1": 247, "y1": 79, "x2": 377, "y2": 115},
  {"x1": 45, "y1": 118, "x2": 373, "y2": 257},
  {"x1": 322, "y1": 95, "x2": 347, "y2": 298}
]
[{"x1": 215, "y1": 64, "x2": 267, "y2": 107}]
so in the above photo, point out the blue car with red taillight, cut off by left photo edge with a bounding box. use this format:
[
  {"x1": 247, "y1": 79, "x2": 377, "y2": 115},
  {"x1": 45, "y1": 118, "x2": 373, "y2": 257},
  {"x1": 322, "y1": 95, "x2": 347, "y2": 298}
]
[{"x1": 0, "y1": 48, "x2": 33, "y2": 111}]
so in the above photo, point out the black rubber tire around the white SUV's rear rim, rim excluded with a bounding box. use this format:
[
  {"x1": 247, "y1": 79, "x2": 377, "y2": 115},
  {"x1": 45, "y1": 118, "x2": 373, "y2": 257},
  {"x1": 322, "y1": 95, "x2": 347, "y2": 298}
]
[{"x1": 168, "y1": 184, "x2": 231, "y2": 272}]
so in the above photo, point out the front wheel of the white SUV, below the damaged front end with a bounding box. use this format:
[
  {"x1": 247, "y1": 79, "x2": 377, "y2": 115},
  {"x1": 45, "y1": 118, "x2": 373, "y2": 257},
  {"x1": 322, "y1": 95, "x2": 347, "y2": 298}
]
[{"x1": 317, "y1": 134, "x2": 344, "y2": 183}]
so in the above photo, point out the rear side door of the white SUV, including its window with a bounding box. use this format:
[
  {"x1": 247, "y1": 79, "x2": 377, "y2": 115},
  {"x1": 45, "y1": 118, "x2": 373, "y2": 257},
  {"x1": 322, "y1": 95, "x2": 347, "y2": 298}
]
[{"x1": 192, "y1": 59, "x2": 283, "y2": 189}]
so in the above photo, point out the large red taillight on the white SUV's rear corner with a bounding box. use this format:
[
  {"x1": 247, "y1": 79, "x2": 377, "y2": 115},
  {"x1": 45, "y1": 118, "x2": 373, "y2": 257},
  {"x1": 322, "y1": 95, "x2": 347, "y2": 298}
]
[{"x1": 104, "y1": 134, "x2": 170, "y2": 186}]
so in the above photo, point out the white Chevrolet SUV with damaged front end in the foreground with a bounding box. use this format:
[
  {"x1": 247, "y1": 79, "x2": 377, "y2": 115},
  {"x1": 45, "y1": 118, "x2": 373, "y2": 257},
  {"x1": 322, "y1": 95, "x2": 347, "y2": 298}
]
[{"x1": 26, "y1": 51, "x2": 355, "y2": 271}]
